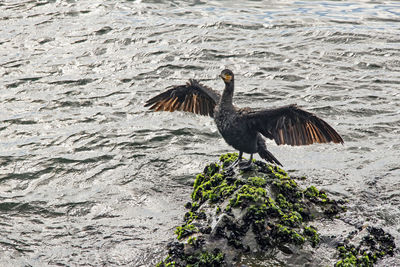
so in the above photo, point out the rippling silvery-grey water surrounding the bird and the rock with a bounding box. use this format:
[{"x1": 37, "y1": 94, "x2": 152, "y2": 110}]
[{"x1": 0, "y1": 0, "x2": 400, "y2": 266}]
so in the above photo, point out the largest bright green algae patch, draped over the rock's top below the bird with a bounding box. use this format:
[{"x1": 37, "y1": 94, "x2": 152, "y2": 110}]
[{"x1": 192, "y1": 153, "x2": 340, "y2": 251}]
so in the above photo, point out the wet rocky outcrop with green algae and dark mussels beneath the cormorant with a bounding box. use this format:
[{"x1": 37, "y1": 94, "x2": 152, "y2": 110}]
[{"x1": 158, "y1": 154, "x2": 395, "y2": 266}]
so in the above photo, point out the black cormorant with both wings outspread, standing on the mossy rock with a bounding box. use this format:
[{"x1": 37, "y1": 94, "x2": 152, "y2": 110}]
[{"x1": 145, "y1": 69, "x2": 343, "y2": 167}]
